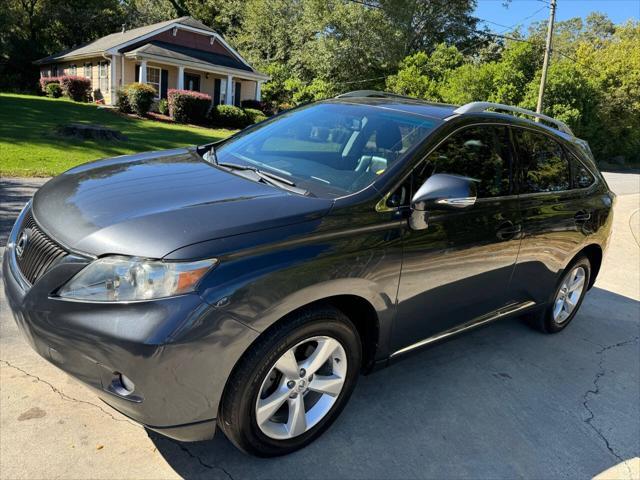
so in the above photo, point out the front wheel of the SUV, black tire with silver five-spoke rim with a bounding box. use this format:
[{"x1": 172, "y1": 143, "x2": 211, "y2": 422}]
[{"x1": 218, "y1": 306, "x2": 362, "y2": 457}]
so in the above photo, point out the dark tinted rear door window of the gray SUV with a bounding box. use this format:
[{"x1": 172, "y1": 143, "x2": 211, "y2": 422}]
[{"x1": 514, "y1": 129, "x2": 571, "y2": 193}]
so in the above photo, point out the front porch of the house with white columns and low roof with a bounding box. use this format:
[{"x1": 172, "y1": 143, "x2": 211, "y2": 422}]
[{"x1": 111, "y1": 42, "x2": 268, "y2": 106}]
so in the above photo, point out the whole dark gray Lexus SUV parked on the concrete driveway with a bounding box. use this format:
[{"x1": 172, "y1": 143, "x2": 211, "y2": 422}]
[{"x1": 3, "y1": 91, "x2": 614, "y2": 456}]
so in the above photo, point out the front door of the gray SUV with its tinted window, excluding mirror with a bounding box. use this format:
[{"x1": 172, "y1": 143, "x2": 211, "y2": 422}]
[{"x1": 393, "y1": 125, "x2": 521, "y2": 350}]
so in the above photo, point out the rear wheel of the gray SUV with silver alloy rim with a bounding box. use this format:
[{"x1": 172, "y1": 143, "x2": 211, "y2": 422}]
[{"x1": 533, "y1": 256, "x2": 591, "y2": 333}]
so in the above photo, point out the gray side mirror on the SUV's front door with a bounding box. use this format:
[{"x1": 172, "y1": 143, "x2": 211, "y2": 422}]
[{"x1": 411, "y1": 173, "x2": 477, "y2": 212}]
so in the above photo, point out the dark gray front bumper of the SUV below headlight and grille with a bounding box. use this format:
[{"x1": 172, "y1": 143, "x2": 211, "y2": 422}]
[{"x1": 2, "y1": 208, "x2": 257, "y2": 441}]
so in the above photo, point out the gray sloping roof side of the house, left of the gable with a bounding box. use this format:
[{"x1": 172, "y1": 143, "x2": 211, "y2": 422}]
[{"x1": 34, "y1": 17, "x2": 216, "y2": 65}]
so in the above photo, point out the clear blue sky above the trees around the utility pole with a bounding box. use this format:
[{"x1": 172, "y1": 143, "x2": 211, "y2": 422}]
[{"x1": 474, "y1": 0, "x2": 640, "y2": 33}]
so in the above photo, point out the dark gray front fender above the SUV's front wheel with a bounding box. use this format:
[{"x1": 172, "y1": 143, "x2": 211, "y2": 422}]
[{"x1": 188, "y1": 216, "x2": 402, "y2": 357}]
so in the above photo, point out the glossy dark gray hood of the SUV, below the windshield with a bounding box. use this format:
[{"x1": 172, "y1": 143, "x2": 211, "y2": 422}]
[{"x1": 33, "y1": 149, "x2": 333, "y2": 258}]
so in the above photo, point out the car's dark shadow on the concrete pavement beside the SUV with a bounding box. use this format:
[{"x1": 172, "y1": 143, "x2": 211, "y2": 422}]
[{"x1": 149, "y1": 288, "x2": 640, "y2": 479}]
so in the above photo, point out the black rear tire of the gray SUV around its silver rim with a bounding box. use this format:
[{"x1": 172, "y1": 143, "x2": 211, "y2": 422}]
[{"x1": 529, "y1": 255, "x2": 591, "y2": 333}]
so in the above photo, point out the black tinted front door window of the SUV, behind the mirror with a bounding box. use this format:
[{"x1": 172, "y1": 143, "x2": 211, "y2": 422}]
[{"x1": 418, "y1": 126, "x2": 512, "y2": 198}]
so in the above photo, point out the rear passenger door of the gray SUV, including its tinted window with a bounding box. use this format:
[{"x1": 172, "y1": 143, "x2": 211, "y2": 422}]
[{"x1": 513, "y1": 127, "x2": 596, "y2": 303}]
